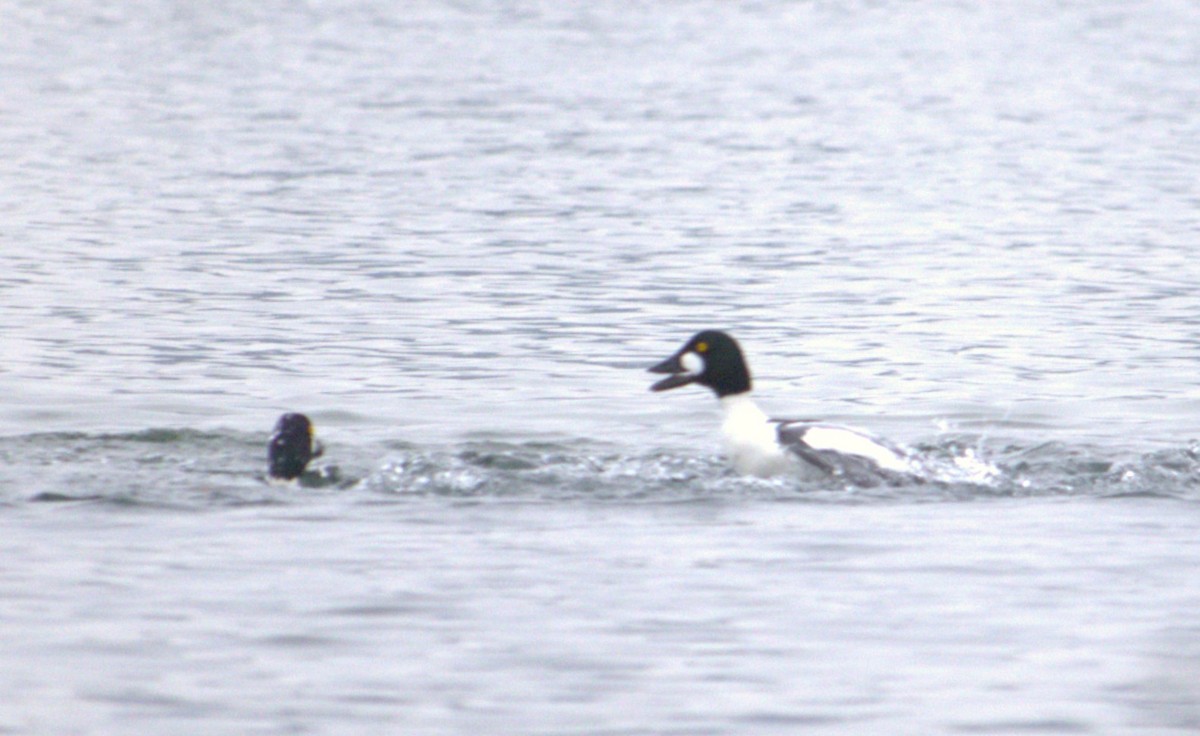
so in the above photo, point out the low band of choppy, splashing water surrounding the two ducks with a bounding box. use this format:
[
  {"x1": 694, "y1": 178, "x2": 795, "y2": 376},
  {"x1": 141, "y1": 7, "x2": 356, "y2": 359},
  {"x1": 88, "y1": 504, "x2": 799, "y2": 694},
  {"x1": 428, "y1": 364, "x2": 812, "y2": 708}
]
[{"x1": 0, "y1": 429, "x2": 1200, "y2": 508}]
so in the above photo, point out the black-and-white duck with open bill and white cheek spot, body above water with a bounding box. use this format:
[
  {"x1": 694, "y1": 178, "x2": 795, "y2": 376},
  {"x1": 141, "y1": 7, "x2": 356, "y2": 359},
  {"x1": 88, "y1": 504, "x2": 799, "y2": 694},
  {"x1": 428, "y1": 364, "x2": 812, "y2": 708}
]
[{"x1": 649, "y1": 330, "x2": 914, "y2": 485}]
